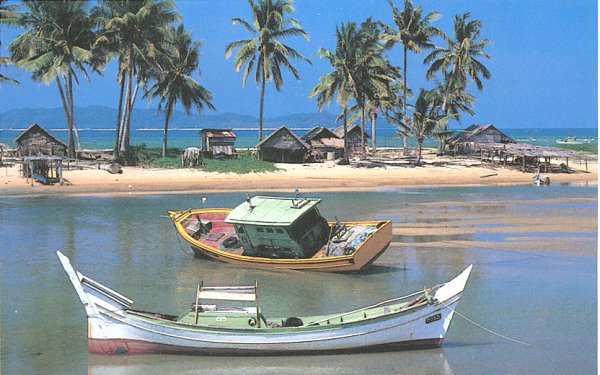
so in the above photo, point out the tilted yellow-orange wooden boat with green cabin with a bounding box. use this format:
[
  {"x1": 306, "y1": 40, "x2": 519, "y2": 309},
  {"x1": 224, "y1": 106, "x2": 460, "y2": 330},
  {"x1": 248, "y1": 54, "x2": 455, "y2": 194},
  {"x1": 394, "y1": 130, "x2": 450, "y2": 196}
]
[{"x1": 169, "y1": 196, "x2": 392, "y2": 272}]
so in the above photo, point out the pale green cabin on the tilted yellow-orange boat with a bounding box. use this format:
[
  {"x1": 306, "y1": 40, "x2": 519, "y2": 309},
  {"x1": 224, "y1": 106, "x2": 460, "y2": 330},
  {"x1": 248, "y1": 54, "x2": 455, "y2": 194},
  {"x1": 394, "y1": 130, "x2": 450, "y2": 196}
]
[{"x1": 225, "y1": 196, "x2": 329, "y2": 258}]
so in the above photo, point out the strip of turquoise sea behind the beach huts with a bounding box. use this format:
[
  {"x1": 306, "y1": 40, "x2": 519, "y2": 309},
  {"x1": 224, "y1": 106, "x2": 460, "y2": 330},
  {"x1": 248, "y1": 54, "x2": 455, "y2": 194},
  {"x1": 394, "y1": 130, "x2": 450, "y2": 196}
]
[{"x1": 0, "y1": 126, "x2": 598, "y2": 149}]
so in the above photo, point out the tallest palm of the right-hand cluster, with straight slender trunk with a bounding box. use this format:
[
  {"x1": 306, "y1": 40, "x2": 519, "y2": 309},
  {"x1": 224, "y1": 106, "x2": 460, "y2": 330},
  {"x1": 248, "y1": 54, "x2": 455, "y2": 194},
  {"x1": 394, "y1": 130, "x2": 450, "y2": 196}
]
[{"x1": 383, "y1": 0, "x2": 444, "y2": 153}]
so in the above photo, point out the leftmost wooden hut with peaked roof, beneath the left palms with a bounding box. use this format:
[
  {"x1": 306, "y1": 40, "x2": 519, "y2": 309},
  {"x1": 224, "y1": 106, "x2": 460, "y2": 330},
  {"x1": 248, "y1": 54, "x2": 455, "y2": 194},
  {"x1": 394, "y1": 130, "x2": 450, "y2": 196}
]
[{"x1": 14, "y1": 124, "x2": 67, "y2": 157}]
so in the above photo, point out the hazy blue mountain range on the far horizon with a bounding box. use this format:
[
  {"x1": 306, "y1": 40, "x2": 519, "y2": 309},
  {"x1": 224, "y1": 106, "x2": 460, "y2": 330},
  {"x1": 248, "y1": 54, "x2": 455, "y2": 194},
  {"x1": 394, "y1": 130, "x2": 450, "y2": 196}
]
[{"x1": 0, "y1": 106, "x2": 388, "y2": 129}]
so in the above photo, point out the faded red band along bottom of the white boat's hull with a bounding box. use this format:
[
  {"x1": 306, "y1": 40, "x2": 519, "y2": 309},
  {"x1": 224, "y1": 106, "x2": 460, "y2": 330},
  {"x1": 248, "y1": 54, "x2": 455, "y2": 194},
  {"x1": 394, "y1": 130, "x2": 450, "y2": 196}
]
[{"x1": 88, "y1": 338, "x2": 444, "y2": 356}]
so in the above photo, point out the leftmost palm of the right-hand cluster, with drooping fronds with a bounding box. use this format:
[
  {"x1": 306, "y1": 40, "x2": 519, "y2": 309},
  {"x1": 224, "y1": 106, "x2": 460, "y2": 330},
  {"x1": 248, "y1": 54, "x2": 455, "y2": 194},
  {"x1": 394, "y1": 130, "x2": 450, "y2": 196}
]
[{"x1": 308, "y1": 22, "x2": 360, "y2": 158}]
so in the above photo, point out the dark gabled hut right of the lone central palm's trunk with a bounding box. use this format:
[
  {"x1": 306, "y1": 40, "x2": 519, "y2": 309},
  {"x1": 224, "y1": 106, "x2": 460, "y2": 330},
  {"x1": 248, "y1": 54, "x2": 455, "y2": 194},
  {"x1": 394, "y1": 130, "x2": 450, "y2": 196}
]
[{"x1": 256, "y1": 126, "x2": 310, "y2": 163}]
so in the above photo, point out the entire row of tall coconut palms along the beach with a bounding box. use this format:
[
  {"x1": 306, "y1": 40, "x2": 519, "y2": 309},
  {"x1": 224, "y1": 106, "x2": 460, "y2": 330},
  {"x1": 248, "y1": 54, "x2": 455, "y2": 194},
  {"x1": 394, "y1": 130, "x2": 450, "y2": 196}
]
[{"x1": 0, "y1": 0, "x2": 491, "y2": 163}]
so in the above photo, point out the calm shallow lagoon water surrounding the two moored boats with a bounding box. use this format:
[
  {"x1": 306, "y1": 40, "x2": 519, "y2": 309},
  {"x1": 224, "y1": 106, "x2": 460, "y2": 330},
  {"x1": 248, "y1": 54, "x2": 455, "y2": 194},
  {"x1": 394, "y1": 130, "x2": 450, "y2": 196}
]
[{"x1": 0, "y1": 186, "x2": 598, "y2": 374}]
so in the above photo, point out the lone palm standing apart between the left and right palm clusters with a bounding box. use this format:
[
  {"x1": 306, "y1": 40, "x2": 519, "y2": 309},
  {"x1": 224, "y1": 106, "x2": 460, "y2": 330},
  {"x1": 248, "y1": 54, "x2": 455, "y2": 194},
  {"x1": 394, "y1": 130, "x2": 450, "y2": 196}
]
[{"x1": 225, "y1": 0, "x2": 310, "y2": 142}]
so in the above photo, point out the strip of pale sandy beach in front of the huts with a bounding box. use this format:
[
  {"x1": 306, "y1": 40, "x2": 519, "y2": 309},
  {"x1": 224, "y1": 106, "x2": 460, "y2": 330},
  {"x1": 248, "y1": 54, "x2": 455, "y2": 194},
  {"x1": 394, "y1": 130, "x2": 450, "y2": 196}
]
[{"x1": 0, "y1": 154, "x2": 598, "y2": 196}]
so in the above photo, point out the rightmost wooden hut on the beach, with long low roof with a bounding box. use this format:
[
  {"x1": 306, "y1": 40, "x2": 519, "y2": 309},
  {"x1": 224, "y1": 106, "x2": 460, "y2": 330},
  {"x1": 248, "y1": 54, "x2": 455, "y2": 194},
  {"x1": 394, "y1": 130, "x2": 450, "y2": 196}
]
[{"x1": 446, "y1": 124, "x2": 516, "y2": 154}]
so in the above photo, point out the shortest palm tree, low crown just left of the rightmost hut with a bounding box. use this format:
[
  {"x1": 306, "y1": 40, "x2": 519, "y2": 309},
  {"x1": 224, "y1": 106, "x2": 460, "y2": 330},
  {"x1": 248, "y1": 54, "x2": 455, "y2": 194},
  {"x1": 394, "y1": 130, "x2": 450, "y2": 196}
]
[{"x1": 394, "y1": 89, "x2": 452, "y2": 165}]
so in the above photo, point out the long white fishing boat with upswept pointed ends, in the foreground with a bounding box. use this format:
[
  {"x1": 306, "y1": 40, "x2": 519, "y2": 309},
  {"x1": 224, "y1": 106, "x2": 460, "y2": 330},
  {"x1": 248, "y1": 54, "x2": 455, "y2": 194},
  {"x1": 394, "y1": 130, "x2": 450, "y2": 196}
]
[{"x1": 57, "y1": 252, "x2": 472, "y2": 355}]
